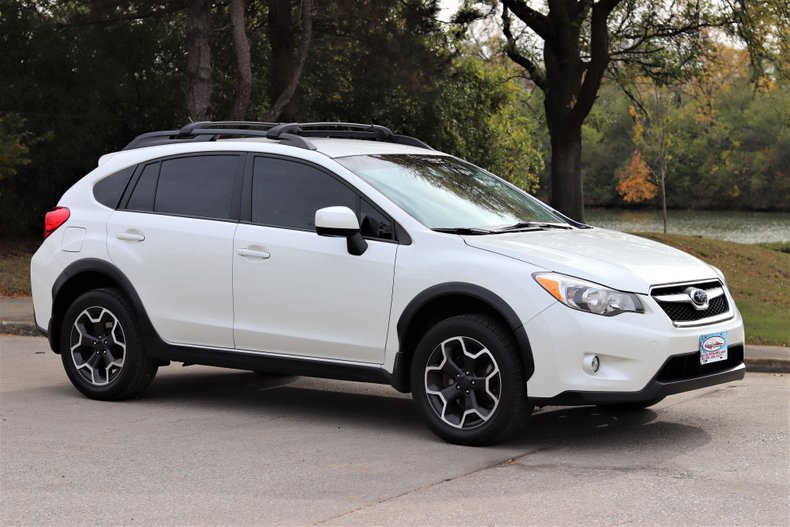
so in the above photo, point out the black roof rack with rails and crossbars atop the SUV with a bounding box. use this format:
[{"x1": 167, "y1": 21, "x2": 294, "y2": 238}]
[{"x1": 123, "y1": 121, "x2": 431, "y2": 150}]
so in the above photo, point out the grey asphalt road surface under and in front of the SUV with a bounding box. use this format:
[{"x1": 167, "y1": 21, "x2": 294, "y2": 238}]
[{"x1": 0, "y1": 337, "x2": 790, "y2": 526}]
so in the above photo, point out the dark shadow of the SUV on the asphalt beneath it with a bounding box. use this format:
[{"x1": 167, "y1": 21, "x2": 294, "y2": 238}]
[{"x1": 127, "y1": 370, "x2": 710, "y2": 451}]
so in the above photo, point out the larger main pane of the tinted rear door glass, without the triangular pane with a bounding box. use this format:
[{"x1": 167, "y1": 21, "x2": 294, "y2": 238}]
[{"x1": 154, "y1": 155, "x2": 239, "y2": 219}]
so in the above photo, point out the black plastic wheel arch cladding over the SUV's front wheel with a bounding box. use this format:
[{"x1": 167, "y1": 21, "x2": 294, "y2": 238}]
[{"x1": 392, "y1": 282, "x2": 535, "y2": 393}]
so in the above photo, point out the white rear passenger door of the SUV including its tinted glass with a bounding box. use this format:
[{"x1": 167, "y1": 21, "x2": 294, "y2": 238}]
[{"x1": 107, "y1": 153, "x2": 243, "y2": 348}]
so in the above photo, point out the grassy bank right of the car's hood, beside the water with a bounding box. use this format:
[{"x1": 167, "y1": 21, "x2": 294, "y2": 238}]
[{"x1": 636, "y1": 233, "x2": 790, "y2": 346}]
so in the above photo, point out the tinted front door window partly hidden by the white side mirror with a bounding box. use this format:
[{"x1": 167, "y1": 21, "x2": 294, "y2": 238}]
[{"x1": 252, "y1": 157, "x2": 358, "y2": 230}]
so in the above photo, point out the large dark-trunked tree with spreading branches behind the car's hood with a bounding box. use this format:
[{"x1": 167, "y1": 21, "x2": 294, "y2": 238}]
[{"x1": 461, "y1": 0, "x2": 786, "y2": 220}]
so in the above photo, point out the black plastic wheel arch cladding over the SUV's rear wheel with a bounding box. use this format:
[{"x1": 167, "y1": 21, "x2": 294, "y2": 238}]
[{"x1": 48, "y1": 258, "x2": 156, "y2": 353}]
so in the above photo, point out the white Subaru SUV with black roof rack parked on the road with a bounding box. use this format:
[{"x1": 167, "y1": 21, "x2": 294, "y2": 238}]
[{"x1": 31, "y1": 122, "x2": 745, "y2": 445}]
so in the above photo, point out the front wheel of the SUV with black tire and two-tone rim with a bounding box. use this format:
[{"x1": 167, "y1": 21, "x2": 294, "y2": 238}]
[{"x1": 411, "y1": 314, "x2": 532, "y2": 446}]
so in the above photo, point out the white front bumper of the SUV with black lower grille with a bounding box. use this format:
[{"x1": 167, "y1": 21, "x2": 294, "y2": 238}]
[{"x1": 524, "y1": 299, "x2": 744, "y2": 404}]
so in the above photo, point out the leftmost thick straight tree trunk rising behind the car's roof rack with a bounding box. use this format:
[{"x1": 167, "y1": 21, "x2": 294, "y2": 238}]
[{"x1": 187, "y1": 0, "x2": 211, "y2": 121}]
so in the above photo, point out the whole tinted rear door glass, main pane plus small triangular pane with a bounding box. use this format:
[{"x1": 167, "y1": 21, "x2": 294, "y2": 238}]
[{"x1": 126, "y1": 155, "x2": 240, "y2": 220}]
